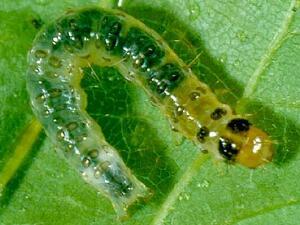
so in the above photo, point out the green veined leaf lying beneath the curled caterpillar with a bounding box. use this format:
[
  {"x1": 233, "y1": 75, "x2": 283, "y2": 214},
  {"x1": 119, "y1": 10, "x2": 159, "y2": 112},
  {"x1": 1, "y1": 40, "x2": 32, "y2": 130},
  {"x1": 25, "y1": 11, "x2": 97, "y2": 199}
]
[{"x1": 0, "y1": 0, "x2": 300, "y2": 225}]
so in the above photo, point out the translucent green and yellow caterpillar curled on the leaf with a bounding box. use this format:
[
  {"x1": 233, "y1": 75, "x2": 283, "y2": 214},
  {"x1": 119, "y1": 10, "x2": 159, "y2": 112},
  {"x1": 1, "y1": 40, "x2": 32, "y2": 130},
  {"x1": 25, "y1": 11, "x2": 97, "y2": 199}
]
[{"x1": 26, "y1": 7, "x2": 273, "y2": 216}]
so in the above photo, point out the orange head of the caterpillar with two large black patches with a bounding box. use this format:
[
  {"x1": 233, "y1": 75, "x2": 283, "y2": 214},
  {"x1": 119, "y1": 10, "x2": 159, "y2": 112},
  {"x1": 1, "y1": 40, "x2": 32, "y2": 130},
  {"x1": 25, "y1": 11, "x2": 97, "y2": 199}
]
[{"x1": 219, "y1": 118, "x2": 273, "y2": 168}]
